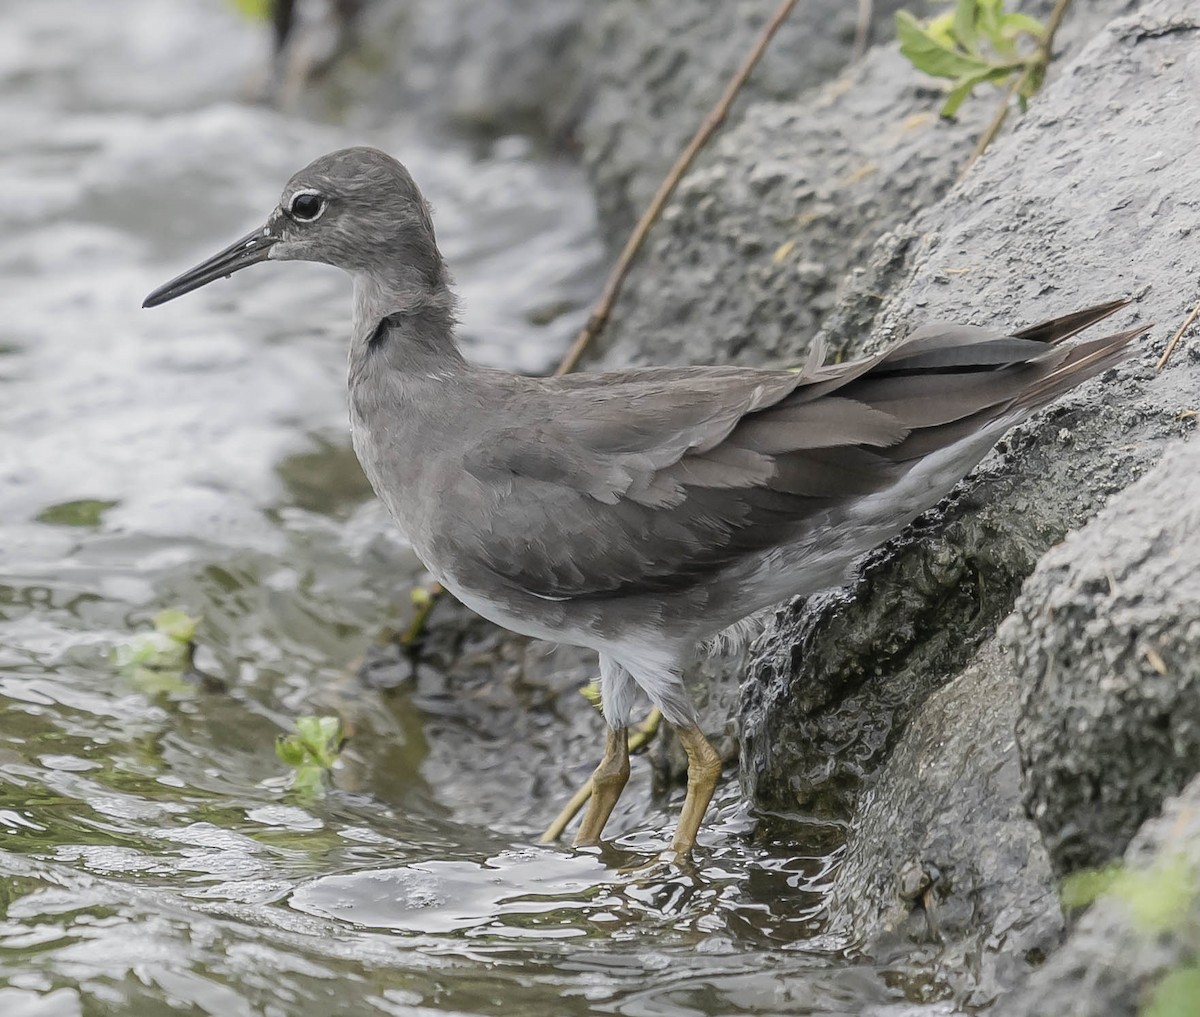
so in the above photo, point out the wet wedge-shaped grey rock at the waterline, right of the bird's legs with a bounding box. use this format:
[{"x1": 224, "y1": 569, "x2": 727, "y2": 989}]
[{"x1": 829, "y1": 642, "x2": 1062, "y2": 1006}]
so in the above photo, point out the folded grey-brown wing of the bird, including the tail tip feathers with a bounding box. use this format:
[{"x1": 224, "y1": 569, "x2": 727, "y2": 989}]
[{"x1": 444, "y1": 303, "x2": 1141, "y2": 600}]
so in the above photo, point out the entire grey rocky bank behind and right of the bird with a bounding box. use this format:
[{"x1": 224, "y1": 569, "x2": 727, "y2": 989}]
[{"x1": 326, "y1": 0, "x2": 1200, "y2": 1015}]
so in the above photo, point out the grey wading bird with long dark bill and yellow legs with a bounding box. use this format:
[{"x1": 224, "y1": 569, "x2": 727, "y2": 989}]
[{"x1": 144, "y1": 148, "x2": 1145, "y2": 854}]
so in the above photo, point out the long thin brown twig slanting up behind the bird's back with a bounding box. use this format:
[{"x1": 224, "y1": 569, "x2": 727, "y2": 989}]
[{"x1": 554, "y1": 0, "x2": 796, "y2": 374}]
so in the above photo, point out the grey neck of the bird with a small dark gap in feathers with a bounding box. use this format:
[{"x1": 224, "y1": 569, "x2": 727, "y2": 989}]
[{"x1": 350, "y1": 273, "x2": 467, "y2": 377}]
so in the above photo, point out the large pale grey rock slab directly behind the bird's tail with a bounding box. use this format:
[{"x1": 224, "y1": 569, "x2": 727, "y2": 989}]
[{"x1": 742, "y1": 0, "x2": 1200, "y2": 808}]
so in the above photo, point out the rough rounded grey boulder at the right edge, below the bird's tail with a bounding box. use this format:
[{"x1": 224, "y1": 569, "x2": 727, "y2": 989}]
[{"x1": 1003, "y1": 443, "x2": 1200, "y2": 874}]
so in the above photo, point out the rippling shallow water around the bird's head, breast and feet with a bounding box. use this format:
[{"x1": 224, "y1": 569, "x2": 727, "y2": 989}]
[{"x1": 0, "y1": 0, "x2": 895, "y2": 1017}]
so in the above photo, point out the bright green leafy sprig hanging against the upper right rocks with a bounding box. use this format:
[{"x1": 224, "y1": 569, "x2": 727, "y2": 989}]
[{"x1": 896, "y1": 0, "x2": 1049, "y2": 116}]
